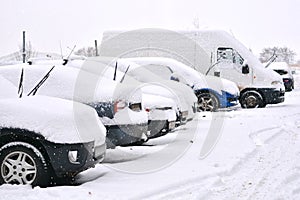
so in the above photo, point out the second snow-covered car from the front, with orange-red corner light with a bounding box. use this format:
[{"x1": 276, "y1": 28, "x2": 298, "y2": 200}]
[{"x1": 0, "y1": 64, "x2": 148, "y2": 148}]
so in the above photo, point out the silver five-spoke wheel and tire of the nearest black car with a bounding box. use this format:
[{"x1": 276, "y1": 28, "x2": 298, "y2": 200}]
[{"x1": 0, "y1": 142, "x2": 50, "y2": 187}]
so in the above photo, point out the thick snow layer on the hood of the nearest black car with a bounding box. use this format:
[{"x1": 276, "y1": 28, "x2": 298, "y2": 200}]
[{"x1": 0, "y1": 96, "x2": 106, "y2": 143}]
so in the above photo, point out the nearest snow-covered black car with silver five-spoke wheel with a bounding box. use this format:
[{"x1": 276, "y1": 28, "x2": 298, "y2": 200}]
[{"x1": 0, "y1": 76, "x2": 106, "y2": 186}]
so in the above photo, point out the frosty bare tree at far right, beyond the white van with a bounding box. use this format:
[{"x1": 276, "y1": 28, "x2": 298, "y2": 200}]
[{"x1": 259, "y1": 47, "x2": 296, "y2": 64}]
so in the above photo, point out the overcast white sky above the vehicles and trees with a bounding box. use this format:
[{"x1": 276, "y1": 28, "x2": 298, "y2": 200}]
[{"x1": 0, "y1": 0, "x2": 300, "y2": 59}]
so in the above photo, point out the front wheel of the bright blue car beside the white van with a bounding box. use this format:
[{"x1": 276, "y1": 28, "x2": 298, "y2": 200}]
[{"x1": 197, "y1": 93, "x2": 219, "y2": 112}]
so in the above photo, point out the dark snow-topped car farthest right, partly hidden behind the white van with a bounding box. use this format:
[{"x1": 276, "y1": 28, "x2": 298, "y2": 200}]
[{"x1": 268, "y1": 62, "x2": 294, "y2": 92}]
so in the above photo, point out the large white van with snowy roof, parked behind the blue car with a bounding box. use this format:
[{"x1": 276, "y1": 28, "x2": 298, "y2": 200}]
[{"x1": 100, "y1": 29, "x2": 285, "y2": 108}]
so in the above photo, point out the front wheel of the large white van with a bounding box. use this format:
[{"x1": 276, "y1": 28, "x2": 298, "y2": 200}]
[{"x1": 240, "y1": 91, "x2": 266, "y2": 108}]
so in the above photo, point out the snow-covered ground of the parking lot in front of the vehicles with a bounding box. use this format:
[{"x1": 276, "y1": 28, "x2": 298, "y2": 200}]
[{"x1": 0, "y1": 71, "x2": 300, "y2": 200}]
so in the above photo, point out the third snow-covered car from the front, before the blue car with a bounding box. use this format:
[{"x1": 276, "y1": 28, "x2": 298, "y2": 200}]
[{"x1": 66, "y1": 58, "x2": 187, "y2": 138}]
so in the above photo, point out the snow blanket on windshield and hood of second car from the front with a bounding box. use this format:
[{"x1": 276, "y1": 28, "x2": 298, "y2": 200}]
[{"x1": 0, "y1": 65, "x2": 141, "y2": 103}]
